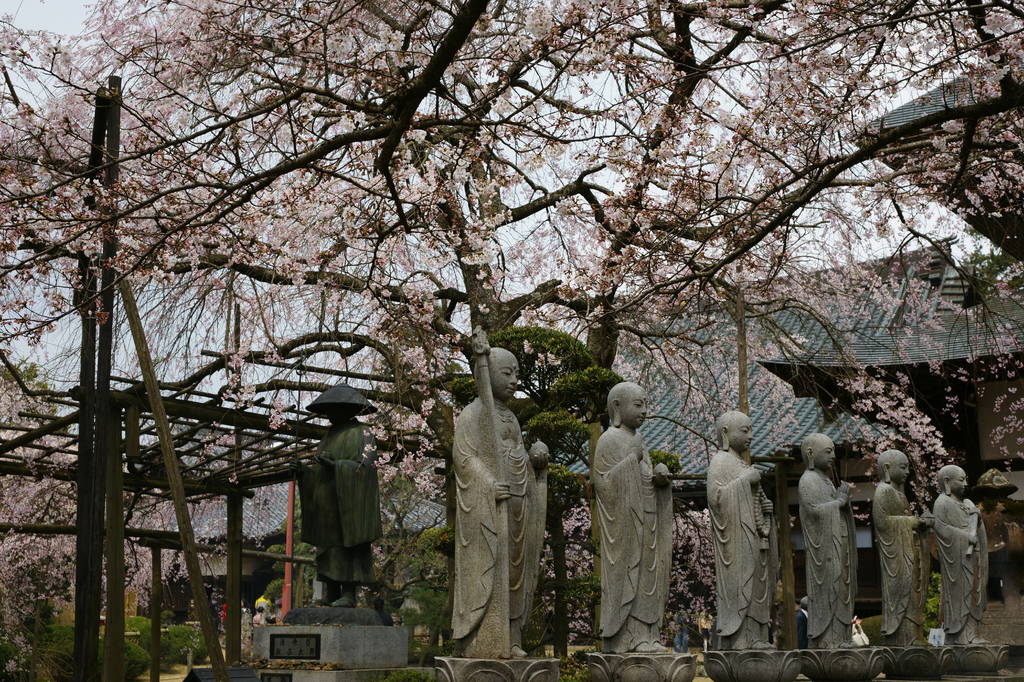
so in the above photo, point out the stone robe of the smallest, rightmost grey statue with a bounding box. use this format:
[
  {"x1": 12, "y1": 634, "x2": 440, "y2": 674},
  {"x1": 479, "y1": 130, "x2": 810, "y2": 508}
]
[{"x1": 932, "y1": 494, "x2": 988, "y2": 644}]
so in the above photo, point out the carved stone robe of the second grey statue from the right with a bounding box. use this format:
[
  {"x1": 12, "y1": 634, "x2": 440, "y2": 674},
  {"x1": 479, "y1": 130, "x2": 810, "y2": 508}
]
[{"x1": 871, "y1": 482, "x2": 931, "y2": 646}]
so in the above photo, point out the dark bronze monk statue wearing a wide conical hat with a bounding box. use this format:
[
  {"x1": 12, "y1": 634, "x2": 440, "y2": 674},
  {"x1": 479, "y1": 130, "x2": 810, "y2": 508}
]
[{"x1": 299, "y1": 384, "x2": 383, "y2": 606}]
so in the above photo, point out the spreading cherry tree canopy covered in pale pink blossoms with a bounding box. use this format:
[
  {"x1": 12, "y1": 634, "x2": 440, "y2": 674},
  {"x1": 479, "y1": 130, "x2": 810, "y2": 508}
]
[{"x1": 0, "y1": 0, "x2": 1024, "y2": 659}]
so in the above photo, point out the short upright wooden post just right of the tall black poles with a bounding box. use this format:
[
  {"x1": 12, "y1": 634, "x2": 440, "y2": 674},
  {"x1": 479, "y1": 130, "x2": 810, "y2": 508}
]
[{"x1": 103, "y1": 411, "x2": 125, "y2": 681}]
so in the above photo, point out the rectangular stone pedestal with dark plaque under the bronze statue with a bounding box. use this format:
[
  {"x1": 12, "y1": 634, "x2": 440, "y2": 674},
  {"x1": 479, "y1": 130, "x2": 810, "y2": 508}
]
[{"x1": 253, "y1": 625, "x2": 409, "y2": 669}]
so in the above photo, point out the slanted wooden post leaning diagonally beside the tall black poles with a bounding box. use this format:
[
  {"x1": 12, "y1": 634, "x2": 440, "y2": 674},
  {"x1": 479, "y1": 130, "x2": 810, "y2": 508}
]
[{"x1": 118, "y1": 280, "x2": 228, "y2": 682}]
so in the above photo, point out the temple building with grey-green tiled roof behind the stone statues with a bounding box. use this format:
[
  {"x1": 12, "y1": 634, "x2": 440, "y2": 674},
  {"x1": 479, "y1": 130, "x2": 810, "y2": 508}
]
[{"x1": 643, "y1": 244, "x2": 1024, "y2": 645}]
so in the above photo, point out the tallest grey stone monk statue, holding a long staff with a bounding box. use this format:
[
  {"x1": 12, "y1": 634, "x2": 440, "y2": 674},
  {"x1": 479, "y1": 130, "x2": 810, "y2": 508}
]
[{"x1": 452, "y1": 329, "x2": 548, "y2": 658}]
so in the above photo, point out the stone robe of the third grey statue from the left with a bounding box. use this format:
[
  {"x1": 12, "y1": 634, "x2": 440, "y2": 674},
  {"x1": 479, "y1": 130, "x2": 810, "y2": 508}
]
[{"x1": 708, "y1": 451, "x2": 778, "y2": 649}]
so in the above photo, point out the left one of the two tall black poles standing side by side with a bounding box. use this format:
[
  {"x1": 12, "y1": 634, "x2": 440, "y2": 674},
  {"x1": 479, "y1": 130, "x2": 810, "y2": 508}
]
[{"x1": 72, "y1": 82, "x2": 110, "y2": 682}]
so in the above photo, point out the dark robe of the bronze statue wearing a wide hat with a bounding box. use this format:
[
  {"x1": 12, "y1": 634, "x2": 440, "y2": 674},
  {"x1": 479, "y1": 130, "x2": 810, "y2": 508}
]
[{"x1": 299, "y1": 420, "x2": 383, "y2": 584}]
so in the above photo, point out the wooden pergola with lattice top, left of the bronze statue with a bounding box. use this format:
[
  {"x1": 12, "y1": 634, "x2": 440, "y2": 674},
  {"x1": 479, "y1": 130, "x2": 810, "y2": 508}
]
[{"x1": 0, "y1": 366, "x2": 327, "y2": 682}]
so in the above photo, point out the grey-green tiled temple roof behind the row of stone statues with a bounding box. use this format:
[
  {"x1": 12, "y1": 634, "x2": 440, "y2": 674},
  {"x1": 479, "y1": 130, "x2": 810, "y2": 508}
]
[{"x1": 641, "y1": 249, "x2": 1007, "y2": 474}]
